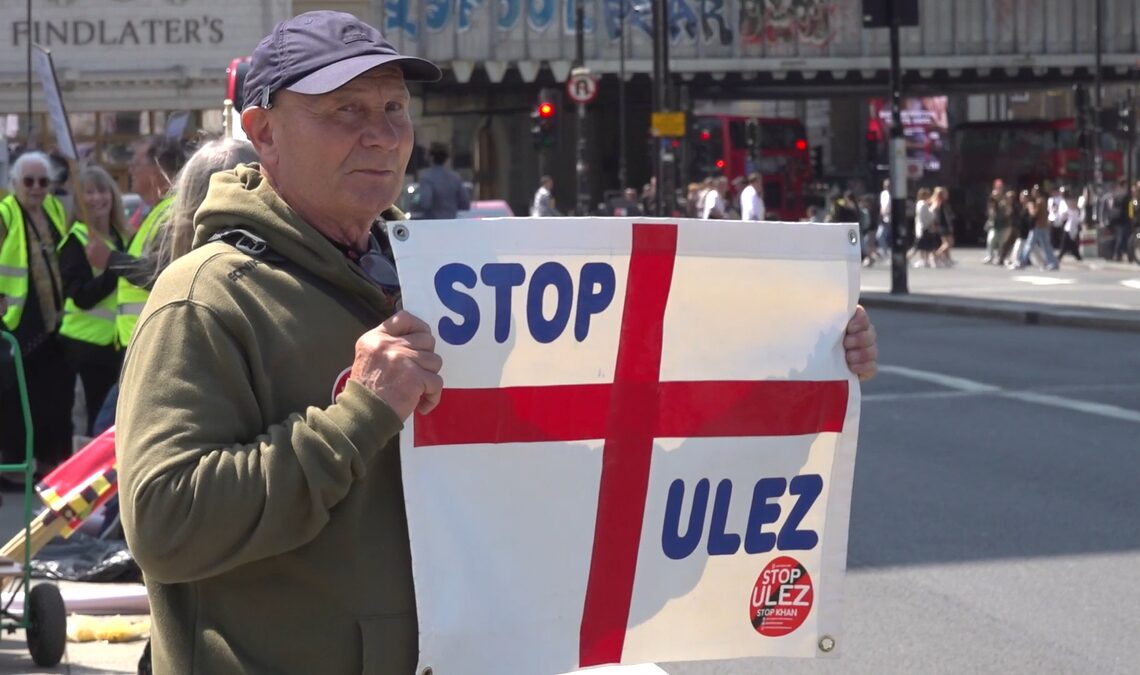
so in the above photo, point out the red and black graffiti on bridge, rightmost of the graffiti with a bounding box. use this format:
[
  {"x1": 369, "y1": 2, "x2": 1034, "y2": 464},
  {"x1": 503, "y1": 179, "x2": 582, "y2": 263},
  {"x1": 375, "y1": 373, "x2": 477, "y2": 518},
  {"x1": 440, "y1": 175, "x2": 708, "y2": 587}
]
[{"x1": 740, "y1": 0, "x2": 839, "y2": 47}]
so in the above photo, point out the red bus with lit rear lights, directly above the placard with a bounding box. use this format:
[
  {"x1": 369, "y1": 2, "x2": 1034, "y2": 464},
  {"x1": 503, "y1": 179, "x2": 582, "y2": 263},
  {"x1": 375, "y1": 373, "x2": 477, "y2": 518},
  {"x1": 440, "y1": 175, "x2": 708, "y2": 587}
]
[{"x1": 689, "y1": 115, "x2": 812, "y2": 220}]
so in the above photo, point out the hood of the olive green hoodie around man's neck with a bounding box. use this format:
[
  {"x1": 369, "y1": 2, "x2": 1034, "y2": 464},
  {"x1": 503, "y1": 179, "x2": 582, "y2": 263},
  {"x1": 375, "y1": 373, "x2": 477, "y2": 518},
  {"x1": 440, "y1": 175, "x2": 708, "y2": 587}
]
[{"x1": 193, "y1": 164, "x2": 405, "y2": 298}]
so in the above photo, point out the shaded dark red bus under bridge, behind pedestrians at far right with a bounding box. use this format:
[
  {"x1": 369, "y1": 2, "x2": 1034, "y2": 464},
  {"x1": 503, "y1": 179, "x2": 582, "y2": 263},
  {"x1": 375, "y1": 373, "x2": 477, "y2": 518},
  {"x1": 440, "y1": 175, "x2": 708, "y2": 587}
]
[{"x1": 948, "y1": 117, "x2": 1124, "y2": 239}]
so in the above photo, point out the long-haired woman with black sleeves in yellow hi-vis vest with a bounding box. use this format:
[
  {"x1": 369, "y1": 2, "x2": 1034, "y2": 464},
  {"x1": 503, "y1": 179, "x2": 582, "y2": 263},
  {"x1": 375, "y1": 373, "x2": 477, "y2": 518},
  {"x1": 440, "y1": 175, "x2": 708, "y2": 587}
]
[{"x1": 59, "y1": 166, "x2": 130, "y2": 436}]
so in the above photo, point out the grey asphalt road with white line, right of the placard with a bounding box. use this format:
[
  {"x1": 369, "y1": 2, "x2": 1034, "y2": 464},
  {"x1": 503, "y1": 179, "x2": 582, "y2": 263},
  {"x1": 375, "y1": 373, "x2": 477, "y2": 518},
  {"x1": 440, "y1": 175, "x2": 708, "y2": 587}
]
[{"x1": 663, "y1": 307, "x2": 1140, "y2": 675}]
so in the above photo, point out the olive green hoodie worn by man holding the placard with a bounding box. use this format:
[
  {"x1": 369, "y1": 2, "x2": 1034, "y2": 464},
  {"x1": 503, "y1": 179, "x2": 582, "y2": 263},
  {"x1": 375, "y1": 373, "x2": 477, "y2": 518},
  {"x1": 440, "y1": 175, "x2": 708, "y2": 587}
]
[{"x1": 116, "y1": 165, "x2": 417, "y2": 675}]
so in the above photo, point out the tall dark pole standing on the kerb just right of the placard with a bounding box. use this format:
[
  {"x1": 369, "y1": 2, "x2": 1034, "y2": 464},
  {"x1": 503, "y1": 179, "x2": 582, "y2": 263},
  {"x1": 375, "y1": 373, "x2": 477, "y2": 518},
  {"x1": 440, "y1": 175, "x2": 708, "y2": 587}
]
[{"x1": 887, "y1": 0, "x2": 909, "y2": 294}]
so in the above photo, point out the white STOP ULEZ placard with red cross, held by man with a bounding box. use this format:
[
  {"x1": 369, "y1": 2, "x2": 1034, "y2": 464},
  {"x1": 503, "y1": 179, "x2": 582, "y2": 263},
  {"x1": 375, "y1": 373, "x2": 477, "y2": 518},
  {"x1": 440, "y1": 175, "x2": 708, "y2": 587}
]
[{"x1": 390, "y1": 218, "x2": 860, "y2": 675}]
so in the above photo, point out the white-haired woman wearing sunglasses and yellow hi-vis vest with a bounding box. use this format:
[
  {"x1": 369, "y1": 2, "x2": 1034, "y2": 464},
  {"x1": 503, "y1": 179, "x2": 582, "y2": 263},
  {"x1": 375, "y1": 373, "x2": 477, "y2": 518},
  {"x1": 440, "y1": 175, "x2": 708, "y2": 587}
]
[{"x1": 0, "y1": 152, "x2": 75, "y2": 483}]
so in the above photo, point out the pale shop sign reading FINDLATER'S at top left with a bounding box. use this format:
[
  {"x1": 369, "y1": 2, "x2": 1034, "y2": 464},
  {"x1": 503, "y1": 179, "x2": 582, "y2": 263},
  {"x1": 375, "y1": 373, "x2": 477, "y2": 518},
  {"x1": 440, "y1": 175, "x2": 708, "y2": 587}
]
[{"x1": 0, "y1": 0, "x2": 281, "y2": 76}]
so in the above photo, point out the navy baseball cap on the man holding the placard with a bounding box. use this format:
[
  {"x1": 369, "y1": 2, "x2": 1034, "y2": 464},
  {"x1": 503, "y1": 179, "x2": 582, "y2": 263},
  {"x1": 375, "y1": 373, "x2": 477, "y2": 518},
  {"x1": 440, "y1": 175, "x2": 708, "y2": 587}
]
[{"x1": 244, "y1": 10, "x2": 443, "y2": 108}]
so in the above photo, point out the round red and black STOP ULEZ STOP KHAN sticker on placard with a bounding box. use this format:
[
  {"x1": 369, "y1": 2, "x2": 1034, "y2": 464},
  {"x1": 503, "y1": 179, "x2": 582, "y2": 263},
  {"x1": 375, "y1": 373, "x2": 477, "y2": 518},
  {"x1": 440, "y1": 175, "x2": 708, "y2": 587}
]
[{"x1": 748, "y1": 555, "x2": 815, "y2": 637}]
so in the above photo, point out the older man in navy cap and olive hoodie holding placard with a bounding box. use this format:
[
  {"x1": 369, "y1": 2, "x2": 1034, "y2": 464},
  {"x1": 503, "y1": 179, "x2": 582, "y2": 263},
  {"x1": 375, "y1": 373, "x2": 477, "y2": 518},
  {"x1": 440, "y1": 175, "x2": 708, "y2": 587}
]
[{"x1": 119, "y1": 11, "x2": 876, "y2": 674}]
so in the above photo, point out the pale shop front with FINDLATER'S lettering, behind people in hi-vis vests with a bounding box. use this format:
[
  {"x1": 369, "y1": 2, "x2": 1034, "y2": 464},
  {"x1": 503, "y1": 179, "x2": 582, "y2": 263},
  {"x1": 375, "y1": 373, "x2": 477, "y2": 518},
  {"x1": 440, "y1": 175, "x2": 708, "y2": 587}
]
[{"x1": 0, "y1": 0, "x2": 292, "y2": 187}]
